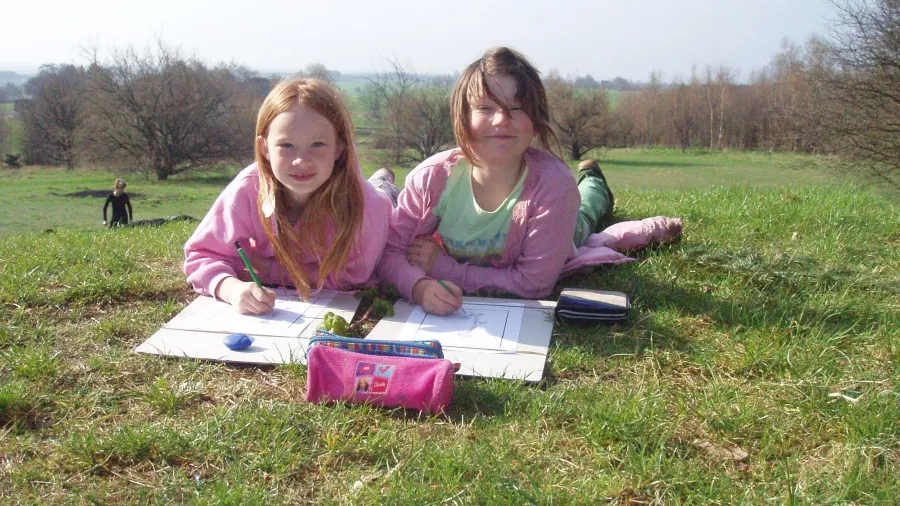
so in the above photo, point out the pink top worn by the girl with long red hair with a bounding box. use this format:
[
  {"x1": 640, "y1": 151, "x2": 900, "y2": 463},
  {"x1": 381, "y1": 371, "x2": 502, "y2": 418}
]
[{"x1": 184, "y1": 163, "x2": 392, "y2": 295}]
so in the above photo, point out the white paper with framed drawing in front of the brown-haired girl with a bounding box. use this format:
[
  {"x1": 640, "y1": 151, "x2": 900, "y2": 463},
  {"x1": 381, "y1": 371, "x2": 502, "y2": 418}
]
[{"x1": 388, "y1": 302, "x2": 525, "y2": 353}]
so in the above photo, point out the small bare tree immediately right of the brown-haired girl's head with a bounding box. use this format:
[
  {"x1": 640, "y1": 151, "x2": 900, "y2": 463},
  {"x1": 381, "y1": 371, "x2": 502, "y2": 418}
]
[{"x1": 546, "y1": 72, "x2": 613, "y2": 160}]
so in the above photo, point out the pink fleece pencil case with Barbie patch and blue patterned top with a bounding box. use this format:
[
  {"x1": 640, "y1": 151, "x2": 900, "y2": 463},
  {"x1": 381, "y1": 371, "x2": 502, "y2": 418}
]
[{"x1": 306, "y1": 336, "x2": 454, "y2": 413}]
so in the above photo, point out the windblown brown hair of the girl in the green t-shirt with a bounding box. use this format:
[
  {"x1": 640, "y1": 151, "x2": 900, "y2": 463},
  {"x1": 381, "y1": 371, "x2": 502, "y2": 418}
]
[{"x1": 450, "y1": 47, "x2": 562, "y2": 162}]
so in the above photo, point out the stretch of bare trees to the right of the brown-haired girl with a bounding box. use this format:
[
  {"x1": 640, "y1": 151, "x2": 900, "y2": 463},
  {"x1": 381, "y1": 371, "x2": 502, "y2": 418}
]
[{"x1": 547, "y1": 0, "x2": 900, "y2": 189}]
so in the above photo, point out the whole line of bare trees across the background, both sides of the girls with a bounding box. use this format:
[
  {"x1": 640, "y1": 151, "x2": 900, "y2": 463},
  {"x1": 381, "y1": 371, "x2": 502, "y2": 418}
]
[{"x1": 0, "y1": 0, "x2": 900, "y2": 187}]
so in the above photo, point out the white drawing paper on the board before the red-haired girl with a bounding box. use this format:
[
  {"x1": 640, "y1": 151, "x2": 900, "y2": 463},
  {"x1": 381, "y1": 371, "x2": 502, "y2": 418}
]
[{"x1": 170, "y1": 288, "x2": 336, "y2": 337}]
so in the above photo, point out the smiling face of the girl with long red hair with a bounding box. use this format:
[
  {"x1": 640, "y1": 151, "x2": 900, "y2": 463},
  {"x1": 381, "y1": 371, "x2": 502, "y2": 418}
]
[{"x1": 256, "y1": 104, "x2": 343, "y2": 205}]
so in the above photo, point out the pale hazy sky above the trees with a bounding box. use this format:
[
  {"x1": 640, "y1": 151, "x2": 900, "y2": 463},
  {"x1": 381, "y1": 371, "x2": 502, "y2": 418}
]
[{"x1": 0, "y1": 0, "x2": 836, "y2": 81}]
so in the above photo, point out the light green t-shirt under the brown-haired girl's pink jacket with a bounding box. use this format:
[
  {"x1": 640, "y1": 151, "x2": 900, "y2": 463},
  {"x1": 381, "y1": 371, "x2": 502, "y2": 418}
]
[{"x1": 434, "y1": 160, "x2": 528, "y2": 266}]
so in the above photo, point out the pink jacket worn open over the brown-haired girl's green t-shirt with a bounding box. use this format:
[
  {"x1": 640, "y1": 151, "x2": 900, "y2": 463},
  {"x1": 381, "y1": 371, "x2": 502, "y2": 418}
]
[{"x1": 378, "y1": 148, "x2": 581, "y2": 300}]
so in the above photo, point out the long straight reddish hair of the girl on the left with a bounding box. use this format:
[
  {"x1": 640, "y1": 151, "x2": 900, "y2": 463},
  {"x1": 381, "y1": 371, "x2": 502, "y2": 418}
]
[{"x1": 255, "y1": 79, "x2": 363, "y2": 298}]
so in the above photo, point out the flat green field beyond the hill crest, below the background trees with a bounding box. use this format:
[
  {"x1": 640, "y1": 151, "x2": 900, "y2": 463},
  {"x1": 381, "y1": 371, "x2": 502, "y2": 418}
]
[{"x1": 0, "y1": 148, "x2": 834, "y2": 236}]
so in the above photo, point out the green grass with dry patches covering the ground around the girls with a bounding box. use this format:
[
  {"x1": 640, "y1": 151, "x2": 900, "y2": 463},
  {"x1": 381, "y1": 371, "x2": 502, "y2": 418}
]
[{"x1": 0, "y1": 152, "x2": 900, "y2": 504}]
